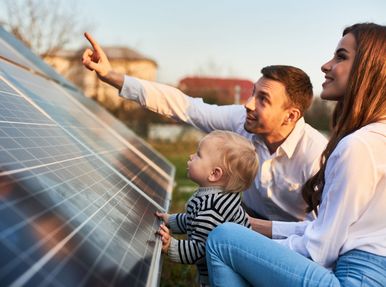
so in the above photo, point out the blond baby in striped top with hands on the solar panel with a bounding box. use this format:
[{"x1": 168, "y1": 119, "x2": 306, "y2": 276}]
[{"x1": 156, "y1": 131, "x2": 258, "y2": 286}]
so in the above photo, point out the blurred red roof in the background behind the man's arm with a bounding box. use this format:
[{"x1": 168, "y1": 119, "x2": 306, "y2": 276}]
[{"x1": 178, "y1": 77, "x2": 253, "y2": 103}]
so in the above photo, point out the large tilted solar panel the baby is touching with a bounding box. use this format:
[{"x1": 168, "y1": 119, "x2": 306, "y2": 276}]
[{"x1": 0, "y1": 29, "x2": 174, "y2": 286}]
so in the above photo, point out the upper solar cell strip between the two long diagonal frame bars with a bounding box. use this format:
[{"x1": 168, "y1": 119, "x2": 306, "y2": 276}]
[{"x1": 0, "y1": 63, "x2": 170, "y2": 206}]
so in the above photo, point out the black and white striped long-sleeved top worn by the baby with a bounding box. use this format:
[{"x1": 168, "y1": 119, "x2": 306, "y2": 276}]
[{"x1": 168, "y1": 187, "x2": 250, "y2": 284}]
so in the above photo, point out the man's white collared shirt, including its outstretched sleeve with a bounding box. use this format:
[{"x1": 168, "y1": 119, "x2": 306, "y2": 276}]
[{"x1": 120, "y1": 76, "x2": 327, "y2": 221}]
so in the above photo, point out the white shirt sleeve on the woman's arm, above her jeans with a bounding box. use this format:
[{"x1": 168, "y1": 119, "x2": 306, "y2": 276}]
[{"x1": 279, "y1": 135, "x2": 376, "y2": 268}]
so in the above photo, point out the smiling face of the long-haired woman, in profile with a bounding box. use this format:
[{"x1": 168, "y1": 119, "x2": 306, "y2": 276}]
[{"x1": 320, "y1": 33, "x2": 356, "y2": 101}]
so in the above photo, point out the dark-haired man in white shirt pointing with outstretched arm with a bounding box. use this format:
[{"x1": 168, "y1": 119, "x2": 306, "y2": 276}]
[{"x1": 82, "y1": 33, "x2": 327, "y2": 225}]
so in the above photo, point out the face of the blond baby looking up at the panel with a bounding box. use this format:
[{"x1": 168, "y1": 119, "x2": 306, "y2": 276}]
[{"x1": 187, "y1": 137, "x2": 220, "y2": 186}]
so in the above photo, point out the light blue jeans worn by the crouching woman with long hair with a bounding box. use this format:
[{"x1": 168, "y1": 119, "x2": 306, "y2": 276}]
[{"x1": 206, "y1": 223, "x2": 386, "y2": 287}]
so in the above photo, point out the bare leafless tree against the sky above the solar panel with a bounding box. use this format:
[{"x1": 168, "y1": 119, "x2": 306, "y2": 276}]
[{"x1": 1, "y1": 0, "x2": 87, "y2": 57}]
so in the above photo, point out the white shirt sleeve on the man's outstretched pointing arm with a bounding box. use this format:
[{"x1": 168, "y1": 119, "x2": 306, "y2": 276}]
[{"x1": 120, "y1": 76, "x2": 246, "y2": 132}]
